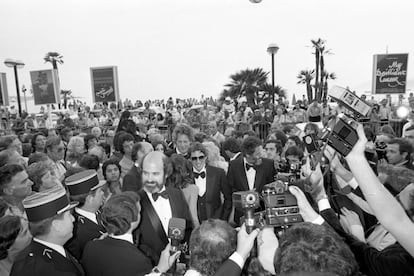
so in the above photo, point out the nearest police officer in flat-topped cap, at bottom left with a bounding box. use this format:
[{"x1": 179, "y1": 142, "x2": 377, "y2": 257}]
[{"x1": 10, "y1": 187, "x2": 85, "y2": 276}]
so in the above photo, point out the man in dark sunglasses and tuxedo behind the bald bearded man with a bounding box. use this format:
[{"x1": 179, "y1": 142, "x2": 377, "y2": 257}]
[{"x1": 190, "y1": 142, "x2": 231, "y2": 223}]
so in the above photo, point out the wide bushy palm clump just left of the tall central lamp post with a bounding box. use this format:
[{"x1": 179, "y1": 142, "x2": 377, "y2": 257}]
[{"x1": 222, "y1": 68, "x2": 269, "y2": 107}]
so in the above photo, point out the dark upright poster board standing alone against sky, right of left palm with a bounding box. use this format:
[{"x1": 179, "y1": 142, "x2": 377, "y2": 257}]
[{"x1": 90, "y1": 66, "x2": 119, "y2": 103}]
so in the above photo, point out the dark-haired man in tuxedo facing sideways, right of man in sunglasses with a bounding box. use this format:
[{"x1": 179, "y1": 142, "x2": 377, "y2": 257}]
[{"x1": 227, "y1": 136, "x2": 276, "y2": 224}]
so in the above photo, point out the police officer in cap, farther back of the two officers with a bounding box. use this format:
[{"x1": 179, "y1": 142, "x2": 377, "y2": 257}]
[{"x1": 65, "y1": 170, "x2": 106, "y2": 260}]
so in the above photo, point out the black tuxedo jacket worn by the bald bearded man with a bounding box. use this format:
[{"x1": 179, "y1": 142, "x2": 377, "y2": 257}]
[{"x1": 135, "y1": 187, "x2": 193, "y2": 265}]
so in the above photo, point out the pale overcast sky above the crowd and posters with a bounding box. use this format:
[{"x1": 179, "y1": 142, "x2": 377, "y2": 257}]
[{"x1": 0, "y1": 0, "x2": 414, "y2": 102}]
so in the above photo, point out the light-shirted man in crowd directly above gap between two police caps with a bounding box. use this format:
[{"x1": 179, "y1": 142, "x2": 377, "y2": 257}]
[{"x1": 46, "y1": 136, "x2": 66, "y2": 182}]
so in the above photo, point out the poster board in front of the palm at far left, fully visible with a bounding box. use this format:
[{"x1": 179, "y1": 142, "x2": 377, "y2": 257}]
[{"x1": 30, "y1": 69, "x2": 60, "y2": 105}]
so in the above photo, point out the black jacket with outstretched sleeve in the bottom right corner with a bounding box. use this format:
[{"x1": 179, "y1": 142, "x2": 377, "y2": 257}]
[{"x1": 321, "y1": 209, "x2": 414, "y2": 276}]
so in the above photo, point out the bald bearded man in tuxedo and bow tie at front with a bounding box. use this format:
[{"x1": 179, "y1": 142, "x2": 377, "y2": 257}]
[{"x1": 136, "y1": 151, "x2": 192, "y2": 265}]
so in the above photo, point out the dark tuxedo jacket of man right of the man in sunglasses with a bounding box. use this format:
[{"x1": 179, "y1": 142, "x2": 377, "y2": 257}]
[{"x1": 227, "y1": 155, "x2": 276, "y2": 224}]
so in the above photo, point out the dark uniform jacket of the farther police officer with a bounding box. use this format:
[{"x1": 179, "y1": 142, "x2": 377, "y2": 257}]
[{"x1": 65, "y1": 210, "x2": 106, "y2": 260}]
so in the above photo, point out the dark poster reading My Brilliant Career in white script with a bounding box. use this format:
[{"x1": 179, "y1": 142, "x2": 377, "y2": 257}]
[{"x1": 372, "y1": 54, "x2": 408, "y2": 94}]
